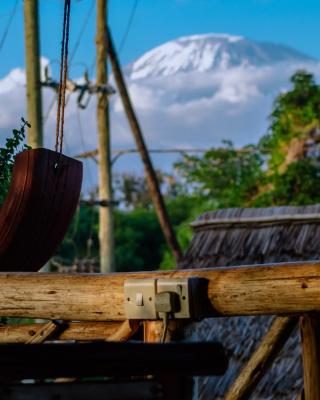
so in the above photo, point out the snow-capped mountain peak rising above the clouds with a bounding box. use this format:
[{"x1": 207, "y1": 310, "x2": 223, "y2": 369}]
[{"x1": 126, "y1": 34, "x2": 311, "y2": 80}]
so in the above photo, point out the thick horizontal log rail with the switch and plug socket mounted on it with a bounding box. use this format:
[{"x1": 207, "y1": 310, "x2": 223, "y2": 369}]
[{"x1": 0, "y1": 262, "x2": 320, "y2": 321}]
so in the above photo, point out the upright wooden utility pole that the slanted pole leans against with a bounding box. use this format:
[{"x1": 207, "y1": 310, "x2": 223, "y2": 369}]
[{"x1": 96, "y1": 0, "x2": 115, "y2": 273}]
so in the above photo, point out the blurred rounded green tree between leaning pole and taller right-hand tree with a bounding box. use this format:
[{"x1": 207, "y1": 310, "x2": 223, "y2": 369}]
[{"x1": 176, "y1": 141, "x2": 263, "y2": 207}]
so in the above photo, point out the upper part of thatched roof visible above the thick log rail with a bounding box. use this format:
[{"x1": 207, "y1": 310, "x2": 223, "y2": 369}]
[{"x1": 180, "y1": 205, "x2": 320, "y2": 268}]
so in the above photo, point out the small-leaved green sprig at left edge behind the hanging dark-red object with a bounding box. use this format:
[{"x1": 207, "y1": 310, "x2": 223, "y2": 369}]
[{"x1": 0, "y1": 117, "x2": 31, "y2": 206}]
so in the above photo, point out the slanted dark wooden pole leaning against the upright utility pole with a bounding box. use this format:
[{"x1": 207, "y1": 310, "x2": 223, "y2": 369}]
[{"x1": 108, "y1": 31, "x2": 182, "y2": 261}]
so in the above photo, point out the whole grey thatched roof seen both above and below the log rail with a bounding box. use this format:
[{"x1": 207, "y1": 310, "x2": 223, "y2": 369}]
[{"x1": 179, "y1": 205, "x2": 320, "y2": 400}]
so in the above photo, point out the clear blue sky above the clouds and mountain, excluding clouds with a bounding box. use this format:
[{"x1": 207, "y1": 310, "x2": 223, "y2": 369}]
[{"x1": 0, "y1": 0, "x2": 320, "y2": 77}]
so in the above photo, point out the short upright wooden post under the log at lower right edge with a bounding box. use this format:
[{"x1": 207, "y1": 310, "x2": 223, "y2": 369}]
[{"x1": 300, "y1": 314, "x2": 320, "y2": 400}]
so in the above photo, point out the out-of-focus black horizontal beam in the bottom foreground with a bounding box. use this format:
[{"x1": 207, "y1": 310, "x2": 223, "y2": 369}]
[{"x1": 0, "y1": 342, "x2": 228, "y2": 382}]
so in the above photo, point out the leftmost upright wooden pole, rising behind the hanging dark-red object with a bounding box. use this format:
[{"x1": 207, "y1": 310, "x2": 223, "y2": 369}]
[{"x1": 24, "y1": 0, "x2": 43, "y2": 148}]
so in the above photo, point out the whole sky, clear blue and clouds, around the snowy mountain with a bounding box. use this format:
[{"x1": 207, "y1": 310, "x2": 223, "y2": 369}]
[{"x1": 0, "y1": 0, "x2": 320, "y2": 187}]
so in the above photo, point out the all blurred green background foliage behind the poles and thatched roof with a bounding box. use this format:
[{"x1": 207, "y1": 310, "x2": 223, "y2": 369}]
[{"x1": 53, "y1": 71, "x2": 320, "y2": 271}]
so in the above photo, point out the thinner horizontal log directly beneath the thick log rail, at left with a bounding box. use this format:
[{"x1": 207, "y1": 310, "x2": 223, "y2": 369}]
[{"x1": 0, "y1": 321, "x2": 139, "y2": 344}]
